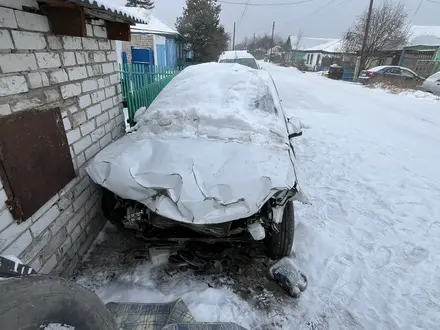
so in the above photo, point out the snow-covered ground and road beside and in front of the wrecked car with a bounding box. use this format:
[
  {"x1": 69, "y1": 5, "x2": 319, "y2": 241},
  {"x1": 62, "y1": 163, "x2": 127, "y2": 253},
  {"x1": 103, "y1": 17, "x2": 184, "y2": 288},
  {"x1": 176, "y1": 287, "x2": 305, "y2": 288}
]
[{"x1": 78, "y1": 64, "x2": 440, "y2": 330}]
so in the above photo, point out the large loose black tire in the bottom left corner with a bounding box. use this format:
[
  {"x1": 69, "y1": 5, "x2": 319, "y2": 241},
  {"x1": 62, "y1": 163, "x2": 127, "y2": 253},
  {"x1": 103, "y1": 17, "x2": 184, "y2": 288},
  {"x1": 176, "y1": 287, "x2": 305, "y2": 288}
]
[{"x1": 0, "y1": 275, "x2": 117, "y2": 330}]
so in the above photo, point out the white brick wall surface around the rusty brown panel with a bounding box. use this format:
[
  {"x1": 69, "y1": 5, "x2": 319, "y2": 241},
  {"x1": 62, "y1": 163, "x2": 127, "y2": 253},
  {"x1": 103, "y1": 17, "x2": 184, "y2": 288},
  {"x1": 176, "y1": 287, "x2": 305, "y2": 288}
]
[{"x1": 0, "y1": 0, "x2": 124, "y2": 274}]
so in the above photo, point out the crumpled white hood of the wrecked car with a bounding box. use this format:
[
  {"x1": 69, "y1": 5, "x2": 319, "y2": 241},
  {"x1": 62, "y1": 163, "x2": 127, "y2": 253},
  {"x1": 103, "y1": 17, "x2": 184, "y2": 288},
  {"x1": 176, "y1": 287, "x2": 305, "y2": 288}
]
[{"x1": 86, "y1": 133, "x2": 305, "y2": 224}]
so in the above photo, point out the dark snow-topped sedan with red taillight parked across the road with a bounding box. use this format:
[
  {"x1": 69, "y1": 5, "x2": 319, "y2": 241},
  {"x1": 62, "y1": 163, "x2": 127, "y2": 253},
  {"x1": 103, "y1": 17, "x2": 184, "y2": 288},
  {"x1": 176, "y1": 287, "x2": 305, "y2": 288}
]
[{"x1": 358, "y1": 65, "x2": 424, "y2": 85}]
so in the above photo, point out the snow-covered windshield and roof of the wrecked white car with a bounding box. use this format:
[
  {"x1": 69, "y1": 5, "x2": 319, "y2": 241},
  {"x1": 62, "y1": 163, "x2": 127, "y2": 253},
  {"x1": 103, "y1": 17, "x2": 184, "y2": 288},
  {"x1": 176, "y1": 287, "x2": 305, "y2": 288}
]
[{"x1": 132, "y1": 63, "x2": 288, "y2": 144}]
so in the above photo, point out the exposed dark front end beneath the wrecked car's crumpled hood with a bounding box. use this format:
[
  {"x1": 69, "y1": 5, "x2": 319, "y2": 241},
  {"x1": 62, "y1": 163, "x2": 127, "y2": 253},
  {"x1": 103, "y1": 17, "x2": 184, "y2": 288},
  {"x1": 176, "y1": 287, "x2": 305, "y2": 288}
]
[{"x1": 103, "y1": 179, "x2": 299, "y2": 242}]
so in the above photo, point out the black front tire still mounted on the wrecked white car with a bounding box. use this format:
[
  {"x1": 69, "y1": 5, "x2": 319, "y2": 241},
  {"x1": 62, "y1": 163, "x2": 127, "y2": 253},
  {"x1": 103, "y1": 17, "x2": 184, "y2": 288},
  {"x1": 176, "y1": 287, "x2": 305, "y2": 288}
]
[{"x1": 266, "y1": 202, "x2": 295, "y2": 260}]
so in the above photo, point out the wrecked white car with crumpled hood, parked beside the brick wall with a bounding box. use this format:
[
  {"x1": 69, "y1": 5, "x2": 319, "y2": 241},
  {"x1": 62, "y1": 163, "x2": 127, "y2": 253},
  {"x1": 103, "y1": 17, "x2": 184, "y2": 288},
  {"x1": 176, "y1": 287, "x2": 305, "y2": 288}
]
[{"x1": 87, "y1": 63, "x2": 306, "y2": 259}]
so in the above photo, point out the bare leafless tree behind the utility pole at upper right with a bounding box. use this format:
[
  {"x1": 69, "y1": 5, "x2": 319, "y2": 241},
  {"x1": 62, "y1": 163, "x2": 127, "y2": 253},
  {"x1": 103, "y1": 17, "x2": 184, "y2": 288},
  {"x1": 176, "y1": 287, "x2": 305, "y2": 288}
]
[{"x1": 343, "y1": 0, "x2": 410, "y2": 70}]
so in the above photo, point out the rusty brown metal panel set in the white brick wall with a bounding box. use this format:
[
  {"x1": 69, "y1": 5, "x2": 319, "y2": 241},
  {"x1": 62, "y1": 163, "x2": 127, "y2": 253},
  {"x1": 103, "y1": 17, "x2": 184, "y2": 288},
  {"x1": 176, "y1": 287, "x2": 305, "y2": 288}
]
[{"x1": 0, "y1": 108, "x2": 75, "y2": 222}]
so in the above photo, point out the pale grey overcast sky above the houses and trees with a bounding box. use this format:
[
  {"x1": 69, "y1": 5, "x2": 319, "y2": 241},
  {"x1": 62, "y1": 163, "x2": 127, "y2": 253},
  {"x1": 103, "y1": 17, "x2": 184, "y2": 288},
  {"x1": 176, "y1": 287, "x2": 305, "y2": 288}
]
[{"x1": 114, "y1": 0, "x2": 440, "y2": 41}]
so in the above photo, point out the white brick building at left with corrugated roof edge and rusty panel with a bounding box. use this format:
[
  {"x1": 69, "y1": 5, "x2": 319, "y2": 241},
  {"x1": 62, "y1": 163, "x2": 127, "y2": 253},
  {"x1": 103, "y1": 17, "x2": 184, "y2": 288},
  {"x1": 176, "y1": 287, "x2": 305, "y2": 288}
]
[{"x1": 0, "y1": 0, "x2": 144, "y2": 275}]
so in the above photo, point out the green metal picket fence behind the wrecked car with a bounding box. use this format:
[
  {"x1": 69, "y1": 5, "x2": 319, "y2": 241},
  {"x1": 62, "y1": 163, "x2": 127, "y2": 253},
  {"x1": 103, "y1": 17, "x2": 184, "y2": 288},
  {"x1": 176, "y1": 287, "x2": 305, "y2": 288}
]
[{"x1": 119, "y1": 64, "x2": 183, "y2": 125}]
